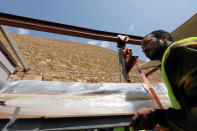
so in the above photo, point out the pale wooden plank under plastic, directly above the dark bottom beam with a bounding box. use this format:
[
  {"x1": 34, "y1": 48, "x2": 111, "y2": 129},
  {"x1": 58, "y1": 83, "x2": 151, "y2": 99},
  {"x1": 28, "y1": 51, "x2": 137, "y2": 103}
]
[{"x1": 0, "y1": 93, "x2": 169, "y2": 119}]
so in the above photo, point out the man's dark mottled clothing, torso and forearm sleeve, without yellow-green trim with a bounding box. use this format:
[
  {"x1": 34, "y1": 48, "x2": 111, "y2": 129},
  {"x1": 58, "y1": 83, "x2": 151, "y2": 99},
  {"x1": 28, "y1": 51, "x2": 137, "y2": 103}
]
[{"x1": 161, "y1": 41, "x2": 197, "y2": 131}]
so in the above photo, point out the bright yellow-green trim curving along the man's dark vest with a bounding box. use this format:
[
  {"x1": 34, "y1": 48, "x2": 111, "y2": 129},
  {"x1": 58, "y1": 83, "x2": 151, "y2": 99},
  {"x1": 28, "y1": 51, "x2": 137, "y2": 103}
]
[{"x1": 161, "y1": 37, "x2": 197, "y2": 109}]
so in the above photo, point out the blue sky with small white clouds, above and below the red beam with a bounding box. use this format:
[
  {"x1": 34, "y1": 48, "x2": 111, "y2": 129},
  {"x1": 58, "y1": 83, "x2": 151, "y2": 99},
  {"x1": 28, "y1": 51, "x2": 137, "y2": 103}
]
[{"x1": 0, "y1": 0, "x2": 197, "y2": 61}]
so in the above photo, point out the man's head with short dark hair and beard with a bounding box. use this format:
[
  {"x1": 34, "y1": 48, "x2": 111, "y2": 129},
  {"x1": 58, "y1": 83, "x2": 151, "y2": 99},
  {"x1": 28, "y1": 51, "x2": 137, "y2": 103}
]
[{"x1": 142, "y1": 30, "x2": 174, "y2": 60}]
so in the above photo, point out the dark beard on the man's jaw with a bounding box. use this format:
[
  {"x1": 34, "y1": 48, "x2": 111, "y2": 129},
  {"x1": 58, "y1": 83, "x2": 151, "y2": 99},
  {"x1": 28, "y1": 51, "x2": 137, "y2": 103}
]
[{"x1": 149, "y1": 46, "x2": 165, "y2": 60}]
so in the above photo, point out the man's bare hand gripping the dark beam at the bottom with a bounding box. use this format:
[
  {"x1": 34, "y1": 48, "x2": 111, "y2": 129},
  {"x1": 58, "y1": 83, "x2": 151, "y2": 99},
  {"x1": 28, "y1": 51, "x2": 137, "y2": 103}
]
[{"x1": 130, "y1": 108, "x2": 157, "y2": 131}]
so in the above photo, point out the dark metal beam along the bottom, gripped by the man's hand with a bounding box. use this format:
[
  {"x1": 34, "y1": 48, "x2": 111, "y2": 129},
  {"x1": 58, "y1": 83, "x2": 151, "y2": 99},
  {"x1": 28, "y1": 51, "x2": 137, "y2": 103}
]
[{"x1": 0, "y1": 115, "x2": 133, "y2": 131}]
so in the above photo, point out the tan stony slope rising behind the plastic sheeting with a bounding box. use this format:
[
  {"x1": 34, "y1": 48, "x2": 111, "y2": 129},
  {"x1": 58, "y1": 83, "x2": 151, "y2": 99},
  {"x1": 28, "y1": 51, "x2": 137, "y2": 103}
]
[{"x1": 0, "y1": 34, "x2": 162, "y2": 83}]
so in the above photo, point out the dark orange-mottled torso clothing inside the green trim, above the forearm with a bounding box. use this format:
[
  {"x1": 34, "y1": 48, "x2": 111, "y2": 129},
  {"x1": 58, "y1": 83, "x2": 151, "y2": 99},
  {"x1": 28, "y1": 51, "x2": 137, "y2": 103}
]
[{"x1": 164, "y1": 42, "x2": 197, "y2": 110}]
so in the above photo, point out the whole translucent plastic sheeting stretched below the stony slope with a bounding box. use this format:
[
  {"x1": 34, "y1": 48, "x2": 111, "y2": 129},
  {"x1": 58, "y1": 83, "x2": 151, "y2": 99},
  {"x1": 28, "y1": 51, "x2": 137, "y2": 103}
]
[{"x1": 0, "y1": 80, "x2": 171, "y2": 117}]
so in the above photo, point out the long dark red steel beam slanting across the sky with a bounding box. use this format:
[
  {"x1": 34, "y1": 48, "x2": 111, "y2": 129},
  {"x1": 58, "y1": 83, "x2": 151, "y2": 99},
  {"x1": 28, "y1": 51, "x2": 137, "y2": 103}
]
[{"x1": 0, "y1": 13, "x2": 142, "y2": 45}]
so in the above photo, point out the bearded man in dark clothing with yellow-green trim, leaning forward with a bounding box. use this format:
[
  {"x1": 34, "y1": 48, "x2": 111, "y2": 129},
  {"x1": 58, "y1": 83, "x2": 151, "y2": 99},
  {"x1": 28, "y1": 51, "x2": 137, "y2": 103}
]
[{"x1": 131, "y1": 30, "x2": 197, "y2": 131}]
